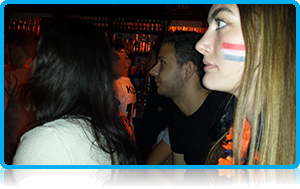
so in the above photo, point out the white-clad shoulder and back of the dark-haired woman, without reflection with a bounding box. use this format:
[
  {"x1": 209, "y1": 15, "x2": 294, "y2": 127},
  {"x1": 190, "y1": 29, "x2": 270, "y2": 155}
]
[{"x1": 14, "y1": 118, "x2": 110, "y2": 165}]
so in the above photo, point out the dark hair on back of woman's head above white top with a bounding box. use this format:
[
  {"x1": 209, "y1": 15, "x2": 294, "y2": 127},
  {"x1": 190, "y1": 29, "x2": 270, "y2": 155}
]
[{"x1": 29, "y1": 18, "x2": 114, "y2": 120}]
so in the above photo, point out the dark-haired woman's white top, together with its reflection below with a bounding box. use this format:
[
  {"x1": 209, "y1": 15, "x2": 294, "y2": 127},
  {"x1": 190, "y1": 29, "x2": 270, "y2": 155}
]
[{"x1": 13, "y1": 119, "x2": 118, "y2": 188}]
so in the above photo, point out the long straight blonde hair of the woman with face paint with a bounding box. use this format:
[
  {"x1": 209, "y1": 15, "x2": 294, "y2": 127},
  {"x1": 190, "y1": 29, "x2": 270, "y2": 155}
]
[{"x1": 206, "y1": 4, "x2": 296, "y2": 187}]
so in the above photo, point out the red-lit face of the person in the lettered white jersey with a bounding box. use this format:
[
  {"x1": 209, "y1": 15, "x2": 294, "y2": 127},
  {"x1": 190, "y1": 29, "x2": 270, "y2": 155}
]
[{"x1": 113, "y1": 50, "x2": 131, "y2": 78}]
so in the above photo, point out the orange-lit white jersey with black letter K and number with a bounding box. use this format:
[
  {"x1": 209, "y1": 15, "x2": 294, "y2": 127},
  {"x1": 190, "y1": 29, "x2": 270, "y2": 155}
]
[{"x1": 114, "y1": 77, "x2": 136, "y2": 130}]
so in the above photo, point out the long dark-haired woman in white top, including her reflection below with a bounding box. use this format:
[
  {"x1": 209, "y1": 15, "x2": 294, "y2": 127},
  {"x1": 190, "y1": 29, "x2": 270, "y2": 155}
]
[{"x1": 13, "y1": 18, "x2": 141, "y2": 188}]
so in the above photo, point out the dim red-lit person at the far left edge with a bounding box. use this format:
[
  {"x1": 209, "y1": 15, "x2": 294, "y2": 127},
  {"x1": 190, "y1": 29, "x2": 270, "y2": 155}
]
[{"x1": 4, "y1": 31, "x2": 38, "y2": 164}]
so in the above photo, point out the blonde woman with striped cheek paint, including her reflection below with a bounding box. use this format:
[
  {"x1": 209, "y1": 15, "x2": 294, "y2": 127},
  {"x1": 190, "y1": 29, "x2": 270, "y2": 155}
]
[{"x1": 196, "y1": 4, "x2": 296, "y2": 187}]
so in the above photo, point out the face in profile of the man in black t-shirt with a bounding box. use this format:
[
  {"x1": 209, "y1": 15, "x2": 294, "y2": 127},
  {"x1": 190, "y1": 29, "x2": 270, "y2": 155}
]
[{"x1": 150, "y1": 44, "x2": 184, "y2": 100}]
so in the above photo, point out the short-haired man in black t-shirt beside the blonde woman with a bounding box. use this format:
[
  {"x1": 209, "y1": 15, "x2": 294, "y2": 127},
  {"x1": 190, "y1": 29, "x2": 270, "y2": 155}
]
[{"x1": 150, "y1": 32, "x2": 232, "y2": 184}]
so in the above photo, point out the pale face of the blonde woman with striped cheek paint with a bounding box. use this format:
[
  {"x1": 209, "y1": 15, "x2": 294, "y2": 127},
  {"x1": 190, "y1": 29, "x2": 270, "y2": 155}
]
[{"x1": 196, "y1": 4, "x2": 246, "y2": 96}]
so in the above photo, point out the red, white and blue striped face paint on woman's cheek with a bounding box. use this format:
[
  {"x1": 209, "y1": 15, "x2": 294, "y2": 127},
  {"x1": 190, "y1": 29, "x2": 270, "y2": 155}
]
[{"x1": 221, "y1": 42, "x2": 245, "y2": 62}]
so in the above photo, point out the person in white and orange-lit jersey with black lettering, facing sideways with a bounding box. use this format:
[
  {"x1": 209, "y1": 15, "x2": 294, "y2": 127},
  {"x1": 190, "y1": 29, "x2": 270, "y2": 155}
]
[{"x1": 112, "y1": 41, "x2": 136, "y2": 131}]
